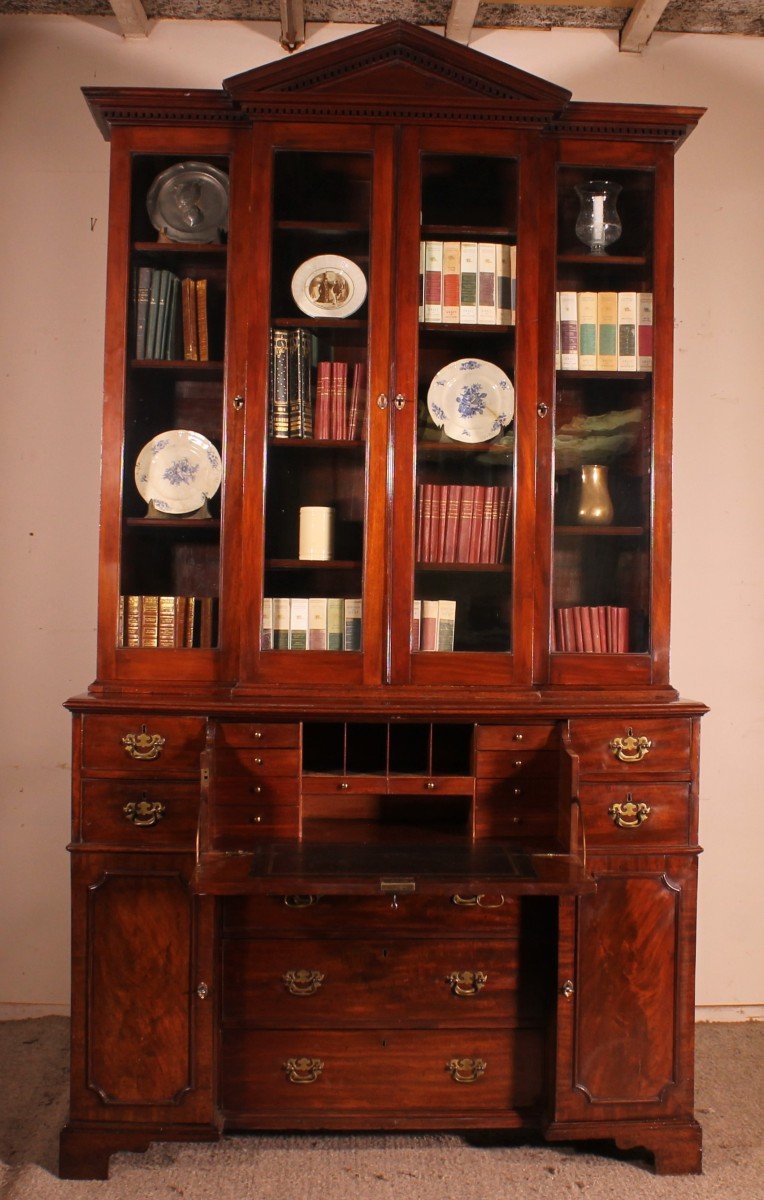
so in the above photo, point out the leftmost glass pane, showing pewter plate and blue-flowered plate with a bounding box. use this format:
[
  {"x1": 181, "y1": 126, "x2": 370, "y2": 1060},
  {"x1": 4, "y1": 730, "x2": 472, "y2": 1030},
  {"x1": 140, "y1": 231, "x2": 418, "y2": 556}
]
[{"x1": 118, "y1": 155, "x2": 228, "y2": 649}]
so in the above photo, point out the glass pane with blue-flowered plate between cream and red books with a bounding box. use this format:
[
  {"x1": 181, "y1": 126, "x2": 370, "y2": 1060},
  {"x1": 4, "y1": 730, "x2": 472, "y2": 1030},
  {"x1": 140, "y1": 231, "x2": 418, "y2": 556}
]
[{"x1": 411, "y1": 155, "x2": 517, "y2": 653}]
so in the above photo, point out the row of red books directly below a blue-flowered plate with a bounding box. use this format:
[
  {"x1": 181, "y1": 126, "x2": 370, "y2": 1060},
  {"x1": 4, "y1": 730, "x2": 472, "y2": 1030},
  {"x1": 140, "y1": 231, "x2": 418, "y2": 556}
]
[{"x1": 416, "y1": 484, "x2": 512, "y2": 563}]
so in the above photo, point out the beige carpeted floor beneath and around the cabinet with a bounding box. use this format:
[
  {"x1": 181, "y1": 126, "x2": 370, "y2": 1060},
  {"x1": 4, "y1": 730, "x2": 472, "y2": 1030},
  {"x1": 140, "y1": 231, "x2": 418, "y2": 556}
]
[{"x1": 0, "y1": 1018, "x2": 764, "y2": 1200}]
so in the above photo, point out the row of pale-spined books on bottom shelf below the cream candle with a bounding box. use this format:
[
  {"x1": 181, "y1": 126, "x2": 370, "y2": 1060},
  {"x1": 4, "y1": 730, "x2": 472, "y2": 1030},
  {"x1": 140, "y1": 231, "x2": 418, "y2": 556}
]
[{"x1": 260, "y1": 596, "x2": 362, "y2": 650}]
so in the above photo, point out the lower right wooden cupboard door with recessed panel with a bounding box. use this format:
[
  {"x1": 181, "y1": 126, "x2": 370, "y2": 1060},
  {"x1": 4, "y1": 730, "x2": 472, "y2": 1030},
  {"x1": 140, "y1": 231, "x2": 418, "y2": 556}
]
[{"x1": 557, "y1": 857, "x2": 696, "y2": 1121}]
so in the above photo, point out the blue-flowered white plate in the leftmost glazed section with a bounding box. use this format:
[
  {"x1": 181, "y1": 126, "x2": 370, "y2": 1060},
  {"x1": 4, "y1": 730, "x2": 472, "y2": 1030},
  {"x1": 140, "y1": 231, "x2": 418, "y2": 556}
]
[{"x1": 136, "y1": 430, "x2": 223, "y2": 514}]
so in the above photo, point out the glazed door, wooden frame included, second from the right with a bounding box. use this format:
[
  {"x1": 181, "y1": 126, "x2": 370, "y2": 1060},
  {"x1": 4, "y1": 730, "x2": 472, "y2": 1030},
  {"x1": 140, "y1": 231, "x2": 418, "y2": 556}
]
[{"x1": 391, "y1": 128, "x2": 537, "y2": 684}]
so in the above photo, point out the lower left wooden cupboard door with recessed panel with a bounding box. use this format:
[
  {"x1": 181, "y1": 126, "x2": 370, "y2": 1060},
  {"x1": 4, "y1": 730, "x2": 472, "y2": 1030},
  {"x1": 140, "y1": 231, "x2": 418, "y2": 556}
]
[{"x1": 71, "y1": 854, "x2": 215, "y2": 1124}]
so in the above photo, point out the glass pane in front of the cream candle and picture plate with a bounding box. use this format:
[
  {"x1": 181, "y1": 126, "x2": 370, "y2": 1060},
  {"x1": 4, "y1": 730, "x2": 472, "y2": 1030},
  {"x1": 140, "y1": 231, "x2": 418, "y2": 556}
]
[{"x1": 260, "y1": 150, "x2": 372, "y2": 652}]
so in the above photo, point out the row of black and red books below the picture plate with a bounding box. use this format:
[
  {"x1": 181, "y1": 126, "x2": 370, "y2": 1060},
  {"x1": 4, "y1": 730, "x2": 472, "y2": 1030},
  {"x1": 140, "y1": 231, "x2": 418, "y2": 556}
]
[{"x1": 269, "y1": 329, "x2": 366, "y2": 442}]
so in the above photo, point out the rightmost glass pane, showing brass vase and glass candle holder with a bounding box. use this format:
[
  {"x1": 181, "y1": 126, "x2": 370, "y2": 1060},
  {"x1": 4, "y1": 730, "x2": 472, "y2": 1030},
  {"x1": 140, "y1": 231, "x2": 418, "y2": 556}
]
[{"x1": 552, "y1": 167, "x2": 652, "y2": 653}]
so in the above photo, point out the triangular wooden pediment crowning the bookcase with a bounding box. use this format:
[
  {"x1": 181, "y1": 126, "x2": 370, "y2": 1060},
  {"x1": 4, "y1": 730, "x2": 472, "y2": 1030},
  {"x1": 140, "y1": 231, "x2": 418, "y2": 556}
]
[{"x1": 224, "y1": 22, "x2": 570, "y2": 114}]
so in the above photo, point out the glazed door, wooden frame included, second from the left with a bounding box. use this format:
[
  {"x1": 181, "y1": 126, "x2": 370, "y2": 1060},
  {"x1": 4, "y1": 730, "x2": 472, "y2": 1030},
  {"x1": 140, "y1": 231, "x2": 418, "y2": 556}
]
[{"x1": 242, "y1": 125, "x2": 393, "y2": 684}]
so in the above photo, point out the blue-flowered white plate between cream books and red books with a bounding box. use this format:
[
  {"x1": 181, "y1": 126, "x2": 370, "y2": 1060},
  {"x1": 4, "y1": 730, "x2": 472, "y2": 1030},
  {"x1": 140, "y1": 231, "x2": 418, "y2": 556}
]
[{"x1": 427, "y1": 359, "x2": 515, "y2": 442}]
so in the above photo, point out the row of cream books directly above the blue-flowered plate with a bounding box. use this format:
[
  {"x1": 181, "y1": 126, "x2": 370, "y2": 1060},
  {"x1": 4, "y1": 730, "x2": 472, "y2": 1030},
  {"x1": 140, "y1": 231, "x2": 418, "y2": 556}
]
[{"x1": 419, "y1": 241, "x2": 517, "y2": 325}]
